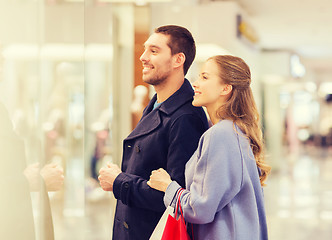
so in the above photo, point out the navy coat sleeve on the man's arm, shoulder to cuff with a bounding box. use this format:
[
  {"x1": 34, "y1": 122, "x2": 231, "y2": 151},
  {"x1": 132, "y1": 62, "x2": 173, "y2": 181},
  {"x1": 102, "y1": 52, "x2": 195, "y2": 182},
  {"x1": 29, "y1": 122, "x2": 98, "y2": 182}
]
[{"x1": 113, "y1": 114, "x2": 205, "y2": 212}]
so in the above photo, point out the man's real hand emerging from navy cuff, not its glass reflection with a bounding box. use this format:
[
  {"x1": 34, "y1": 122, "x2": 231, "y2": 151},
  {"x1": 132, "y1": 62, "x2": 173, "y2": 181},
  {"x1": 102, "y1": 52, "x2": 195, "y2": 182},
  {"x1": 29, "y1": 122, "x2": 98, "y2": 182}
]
[{"x1": 98, "y1": 163, "x2": 121, "y2": 191}]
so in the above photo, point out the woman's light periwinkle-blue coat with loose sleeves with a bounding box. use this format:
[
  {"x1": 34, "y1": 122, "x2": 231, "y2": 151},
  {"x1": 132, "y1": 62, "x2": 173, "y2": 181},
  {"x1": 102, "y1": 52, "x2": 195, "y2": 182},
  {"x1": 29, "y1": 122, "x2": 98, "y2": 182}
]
[{"x1": 164, "y1": 120, "x2": 268, "y2": 240}]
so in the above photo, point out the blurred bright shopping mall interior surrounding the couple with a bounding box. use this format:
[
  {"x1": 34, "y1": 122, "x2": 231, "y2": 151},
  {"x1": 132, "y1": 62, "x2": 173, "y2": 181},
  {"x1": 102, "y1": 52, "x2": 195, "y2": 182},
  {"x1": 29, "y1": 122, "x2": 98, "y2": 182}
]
[{"x1": 0, "y1": 0, "x2": 332, "y2": 240}]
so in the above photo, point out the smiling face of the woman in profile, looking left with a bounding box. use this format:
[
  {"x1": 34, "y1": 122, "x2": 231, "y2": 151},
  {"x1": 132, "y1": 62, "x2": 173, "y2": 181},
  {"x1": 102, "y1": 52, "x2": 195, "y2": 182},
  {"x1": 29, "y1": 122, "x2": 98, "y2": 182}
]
[{"x1": 192, "y1": 59, "x2": 225, "y2": 110}]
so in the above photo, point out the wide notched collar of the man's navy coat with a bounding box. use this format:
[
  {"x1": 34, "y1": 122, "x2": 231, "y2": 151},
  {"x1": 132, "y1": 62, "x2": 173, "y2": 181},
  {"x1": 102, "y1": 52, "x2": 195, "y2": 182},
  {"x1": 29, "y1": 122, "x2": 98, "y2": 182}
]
[{"x1": 126, "y1": 79, "x2": 194, "y2": 140}]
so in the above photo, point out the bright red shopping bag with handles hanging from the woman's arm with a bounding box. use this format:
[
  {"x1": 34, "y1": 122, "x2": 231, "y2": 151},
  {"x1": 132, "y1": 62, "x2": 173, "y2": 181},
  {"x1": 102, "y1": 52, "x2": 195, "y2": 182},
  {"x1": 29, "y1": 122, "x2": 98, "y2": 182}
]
[{"x1": 161, "y1": 189, "x2": 190, "y2": 240}]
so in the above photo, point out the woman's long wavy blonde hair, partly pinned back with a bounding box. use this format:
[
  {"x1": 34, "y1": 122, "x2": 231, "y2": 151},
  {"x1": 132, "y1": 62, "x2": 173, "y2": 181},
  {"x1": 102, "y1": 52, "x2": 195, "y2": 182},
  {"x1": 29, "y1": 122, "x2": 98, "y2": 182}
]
[{"x1": 208, "y1": 55, "x2": 271, "y2": 186}]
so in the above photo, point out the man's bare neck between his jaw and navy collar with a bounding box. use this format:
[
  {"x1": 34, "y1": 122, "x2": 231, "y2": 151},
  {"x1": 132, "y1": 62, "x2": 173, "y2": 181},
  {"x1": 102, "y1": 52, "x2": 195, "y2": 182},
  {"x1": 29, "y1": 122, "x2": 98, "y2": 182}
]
[{"x1": 154, "y1": 75, "x2": 184, "y2": 103}]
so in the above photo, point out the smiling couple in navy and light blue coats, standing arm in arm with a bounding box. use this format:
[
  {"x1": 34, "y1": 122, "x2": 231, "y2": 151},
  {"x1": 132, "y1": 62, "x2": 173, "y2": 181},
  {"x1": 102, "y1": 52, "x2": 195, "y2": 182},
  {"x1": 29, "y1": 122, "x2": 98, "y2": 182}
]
[{"x1": 99, "y1": 25, "x2": 270, "y2": 240}]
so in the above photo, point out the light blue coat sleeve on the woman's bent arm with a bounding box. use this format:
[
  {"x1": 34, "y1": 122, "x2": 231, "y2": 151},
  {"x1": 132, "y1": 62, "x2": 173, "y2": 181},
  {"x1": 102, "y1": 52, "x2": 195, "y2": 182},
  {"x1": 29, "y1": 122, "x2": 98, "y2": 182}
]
[{"x1": 165, "y1": 124, "x2": 243, "y2": 224}]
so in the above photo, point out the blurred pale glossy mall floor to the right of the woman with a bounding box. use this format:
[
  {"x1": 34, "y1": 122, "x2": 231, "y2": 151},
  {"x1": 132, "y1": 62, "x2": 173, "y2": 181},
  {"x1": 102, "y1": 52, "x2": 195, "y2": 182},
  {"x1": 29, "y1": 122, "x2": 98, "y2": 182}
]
[{"x1": 265, "y1": 147, "x2": 332, "y2": 240}]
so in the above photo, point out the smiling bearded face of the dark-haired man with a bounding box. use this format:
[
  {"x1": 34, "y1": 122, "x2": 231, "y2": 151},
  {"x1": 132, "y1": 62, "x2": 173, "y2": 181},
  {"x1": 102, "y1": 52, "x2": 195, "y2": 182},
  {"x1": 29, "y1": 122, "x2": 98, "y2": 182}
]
[{"x1": 140, "y1": 33, "x2": 173, "y2": 85}]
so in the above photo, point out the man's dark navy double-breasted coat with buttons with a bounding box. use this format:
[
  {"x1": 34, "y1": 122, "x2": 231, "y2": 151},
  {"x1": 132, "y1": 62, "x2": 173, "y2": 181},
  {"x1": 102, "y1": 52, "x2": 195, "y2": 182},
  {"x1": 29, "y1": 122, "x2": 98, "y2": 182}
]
[{"x1": 113, "y1": 79, "x2": 208, "y2": 240}]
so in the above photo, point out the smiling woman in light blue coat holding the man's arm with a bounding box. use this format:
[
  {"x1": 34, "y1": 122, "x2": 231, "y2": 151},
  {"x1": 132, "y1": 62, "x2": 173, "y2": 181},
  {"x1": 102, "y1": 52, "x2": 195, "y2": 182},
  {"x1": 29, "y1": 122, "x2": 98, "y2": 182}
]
[{"x1": 148, "y1": 55, "x2": 270, "y2": 240}]
